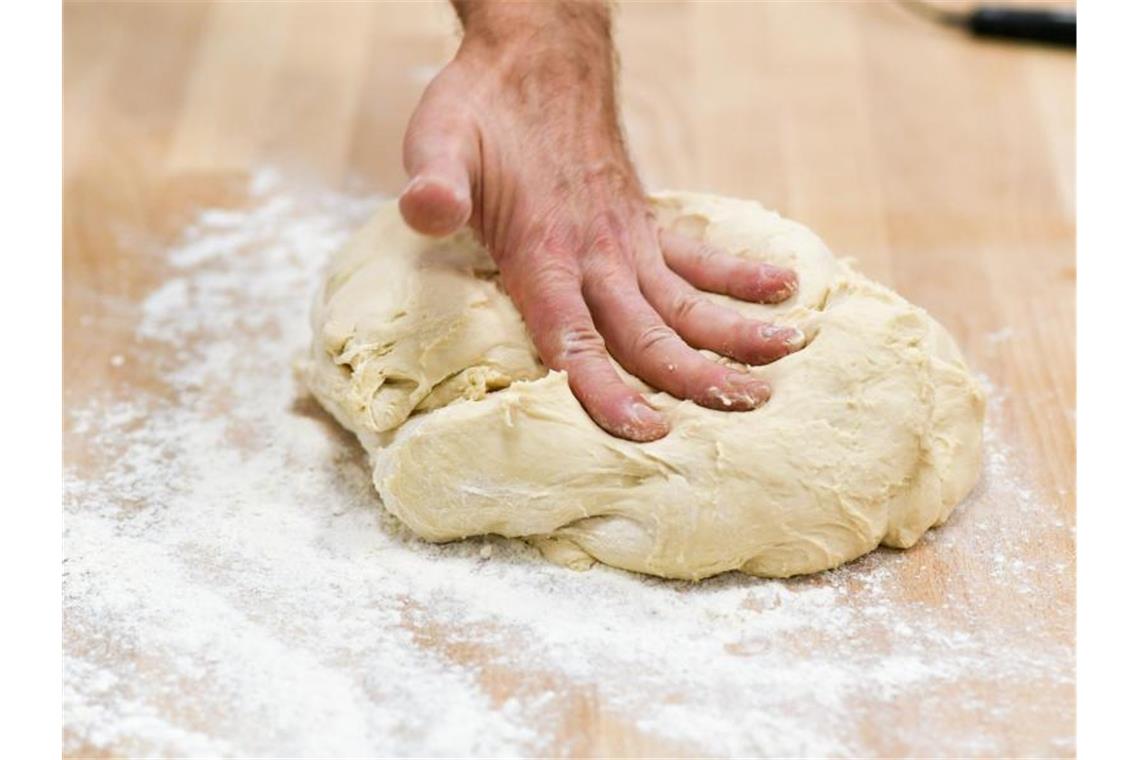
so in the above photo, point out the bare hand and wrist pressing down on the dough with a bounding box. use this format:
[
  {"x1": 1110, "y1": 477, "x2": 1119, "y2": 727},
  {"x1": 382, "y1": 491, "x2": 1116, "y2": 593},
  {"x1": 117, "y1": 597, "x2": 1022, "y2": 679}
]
[{"x1": 400, "y1": 0, "x2": 804, "y2": 441}]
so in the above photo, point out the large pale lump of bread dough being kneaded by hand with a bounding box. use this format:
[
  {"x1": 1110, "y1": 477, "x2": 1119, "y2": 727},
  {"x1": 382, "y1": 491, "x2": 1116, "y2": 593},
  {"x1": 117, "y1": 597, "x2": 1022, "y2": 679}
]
[{"x1": 302, "y1": 193, "x2": 984, "y2": 579}]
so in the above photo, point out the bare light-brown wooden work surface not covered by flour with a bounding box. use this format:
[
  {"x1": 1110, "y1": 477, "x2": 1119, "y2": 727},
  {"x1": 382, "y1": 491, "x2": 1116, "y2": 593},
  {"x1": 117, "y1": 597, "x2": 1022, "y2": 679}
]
[{"x1": 64, "y1": 2, "x2": 1075, "y2": 754}]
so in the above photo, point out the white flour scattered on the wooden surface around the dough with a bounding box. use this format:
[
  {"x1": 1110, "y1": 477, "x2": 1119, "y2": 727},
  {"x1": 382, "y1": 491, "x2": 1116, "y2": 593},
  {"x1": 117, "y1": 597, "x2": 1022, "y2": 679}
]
[{"x1": 64, "y1": 171, "x2": 1073, "y2": 755}]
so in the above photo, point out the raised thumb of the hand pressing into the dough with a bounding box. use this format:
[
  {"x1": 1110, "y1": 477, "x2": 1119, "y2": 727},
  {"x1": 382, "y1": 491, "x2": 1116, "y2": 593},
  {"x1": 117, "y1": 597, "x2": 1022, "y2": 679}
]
[{"x1": 400, "y1": 81, "x2": 477, "y2": 236}]
